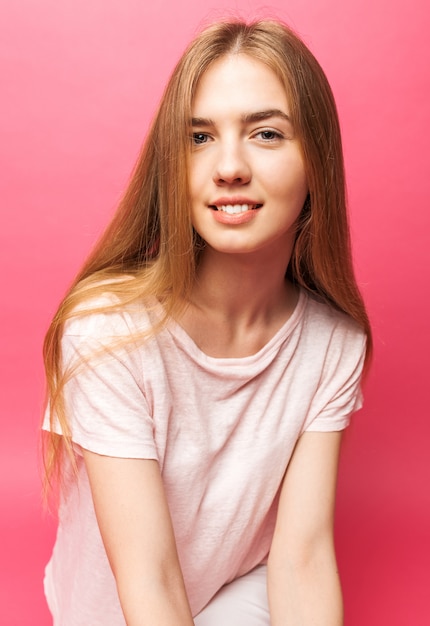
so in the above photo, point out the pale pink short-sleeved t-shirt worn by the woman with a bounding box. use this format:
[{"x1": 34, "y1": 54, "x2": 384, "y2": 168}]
[{"x1": 45, "y1": 292, "x2": 365, "y2": 626}]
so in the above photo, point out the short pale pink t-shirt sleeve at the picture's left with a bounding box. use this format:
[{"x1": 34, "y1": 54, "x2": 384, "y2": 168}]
[{"x1": 44, "y1": 313, "x2": 158, "y2": 459}]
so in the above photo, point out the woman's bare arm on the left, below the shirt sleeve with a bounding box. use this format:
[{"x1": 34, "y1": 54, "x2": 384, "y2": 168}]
[{"x1": 83, "y1": 450, "x2": 194, "y2": 626}]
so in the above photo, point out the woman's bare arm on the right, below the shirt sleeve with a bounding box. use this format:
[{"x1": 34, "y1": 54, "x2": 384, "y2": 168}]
[{"x1": 267, "y1": 432, "x2": 343, "y2": 626}]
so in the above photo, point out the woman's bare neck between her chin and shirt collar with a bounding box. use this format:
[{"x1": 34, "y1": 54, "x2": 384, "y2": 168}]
[{"x1": 177, "y1": 250, "x2": 298, "y2": 358}]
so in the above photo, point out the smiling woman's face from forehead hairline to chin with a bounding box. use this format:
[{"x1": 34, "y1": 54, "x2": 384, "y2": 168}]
[{"x1": 190, "y1": 54, "x2": 308, "y2": 253}]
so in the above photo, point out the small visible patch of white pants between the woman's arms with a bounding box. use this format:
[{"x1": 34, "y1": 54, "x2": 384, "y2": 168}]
[{"x1": 194, "y1": 565, "x2": 270, "y2": 626}]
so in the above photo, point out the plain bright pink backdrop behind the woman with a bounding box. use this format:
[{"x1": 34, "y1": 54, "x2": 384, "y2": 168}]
[{"x1": 0, "y1": 0, "x2": 430, "y2": 626}]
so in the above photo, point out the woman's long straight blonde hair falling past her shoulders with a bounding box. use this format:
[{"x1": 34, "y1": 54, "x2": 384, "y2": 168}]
[{"x1": 44, "y1": 20, "x2": 371, "y2": 494}]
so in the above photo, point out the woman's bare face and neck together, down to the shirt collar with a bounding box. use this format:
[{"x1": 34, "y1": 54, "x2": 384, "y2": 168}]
[{"x1": 186, "y1": 55, "x2": 308, "y2": 356}]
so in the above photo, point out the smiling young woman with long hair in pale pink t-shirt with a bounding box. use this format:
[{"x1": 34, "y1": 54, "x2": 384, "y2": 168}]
[{"x1": 44, "y1": 21, "x2": 370, "y2": 626}]
